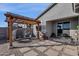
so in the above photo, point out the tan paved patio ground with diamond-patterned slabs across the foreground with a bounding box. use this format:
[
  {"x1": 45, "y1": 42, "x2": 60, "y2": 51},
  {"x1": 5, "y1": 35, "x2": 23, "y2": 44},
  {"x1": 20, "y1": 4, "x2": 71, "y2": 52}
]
[{"x1": 0, "y1": 40, "x2": 79, "y2": 56}]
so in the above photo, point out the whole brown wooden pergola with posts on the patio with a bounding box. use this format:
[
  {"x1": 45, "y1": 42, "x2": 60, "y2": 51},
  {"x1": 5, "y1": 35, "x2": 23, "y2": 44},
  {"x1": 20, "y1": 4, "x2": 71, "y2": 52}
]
[{"x1": 4, "y1": 12, "x2": 41, "y2": 48}]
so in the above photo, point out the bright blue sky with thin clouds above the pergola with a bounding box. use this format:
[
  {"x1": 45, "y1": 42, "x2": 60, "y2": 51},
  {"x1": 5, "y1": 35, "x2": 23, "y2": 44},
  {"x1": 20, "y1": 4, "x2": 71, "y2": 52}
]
[{"x1": 0, "y1": 3, "x2": 49, "y2": 27}]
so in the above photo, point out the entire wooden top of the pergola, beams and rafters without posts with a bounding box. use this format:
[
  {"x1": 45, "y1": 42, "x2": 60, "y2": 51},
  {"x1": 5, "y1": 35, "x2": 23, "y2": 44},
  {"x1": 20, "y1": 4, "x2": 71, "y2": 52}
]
[{"x1": 4, "y1": 12, "x2": 40, "y2": 24}]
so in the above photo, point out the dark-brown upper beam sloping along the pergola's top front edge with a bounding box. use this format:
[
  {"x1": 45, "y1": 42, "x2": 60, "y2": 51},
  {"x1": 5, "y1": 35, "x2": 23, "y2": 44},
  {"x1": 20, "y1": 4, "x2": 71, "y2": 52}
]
[{"x1": 4, "y1": 12, "x2": 41, "y2": 23}]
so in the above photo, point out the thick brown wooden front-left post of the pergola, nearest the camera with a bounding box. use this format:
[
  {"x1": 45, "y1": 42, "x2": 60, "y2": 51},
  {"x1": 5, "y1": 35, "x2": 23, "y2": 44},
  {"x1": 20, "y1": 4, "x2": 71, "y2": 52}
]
[{"x1": 8, "y1": 17, "x2": 13, "y2": 48}]
